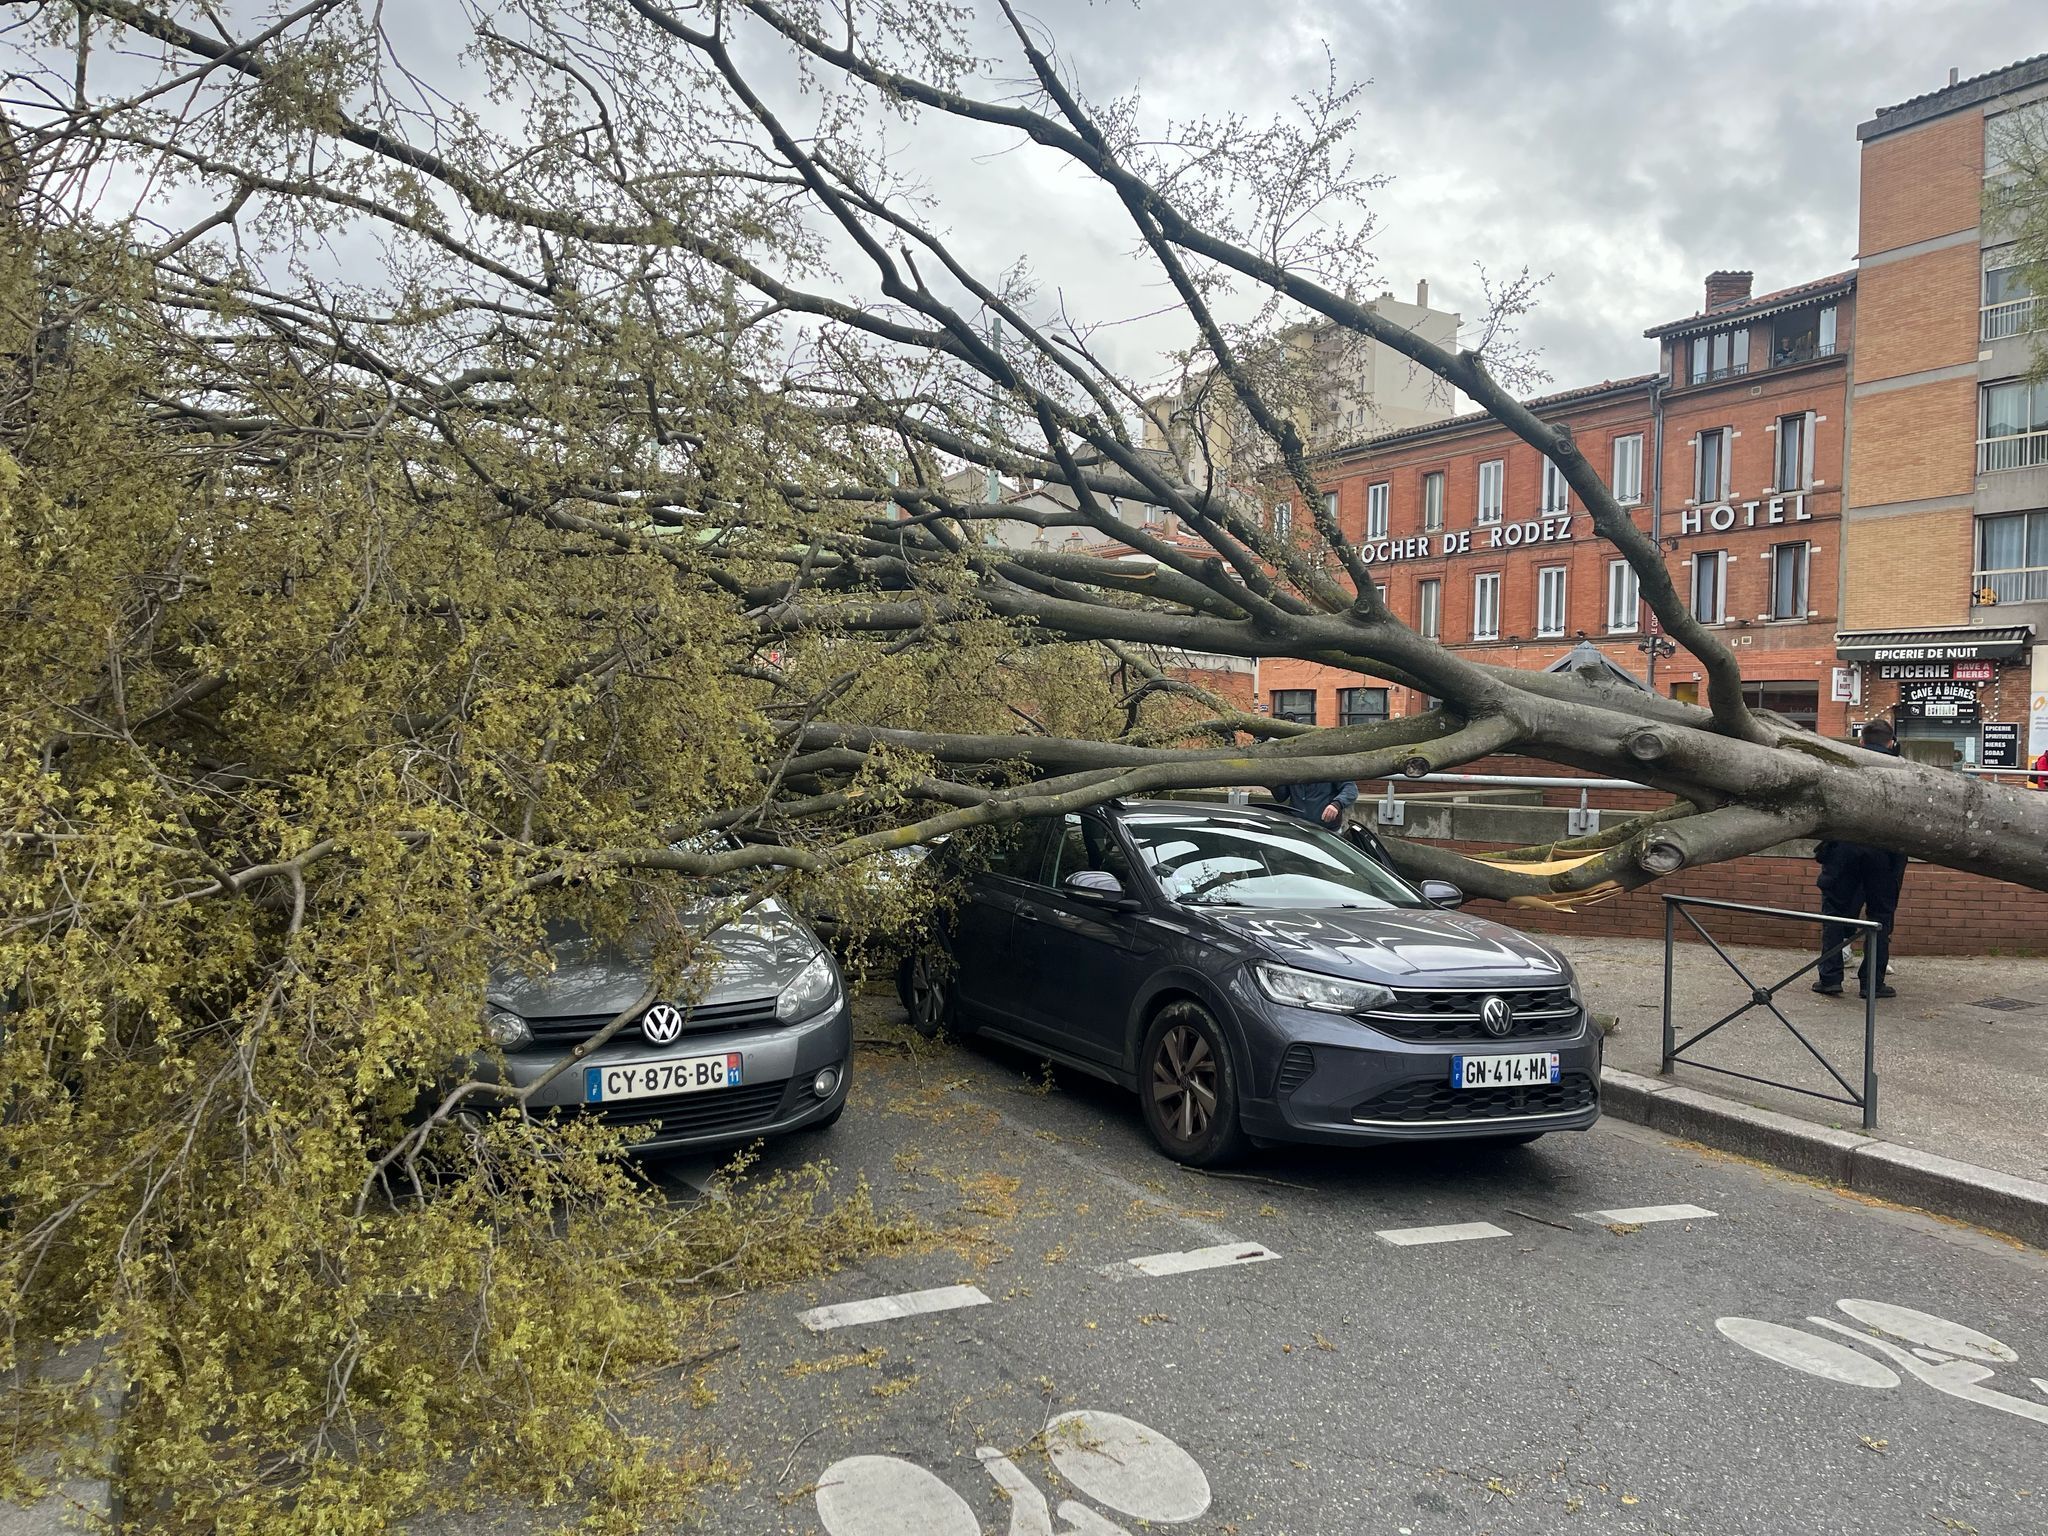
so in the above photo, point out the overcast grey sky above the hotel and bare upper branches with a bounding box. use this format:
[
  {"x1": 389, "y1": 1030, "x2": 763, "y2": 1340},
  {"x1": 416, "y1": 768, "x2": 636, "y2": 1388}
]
[{"x1": 868, "y1": 0, "x2": 2048, "y2": 403}]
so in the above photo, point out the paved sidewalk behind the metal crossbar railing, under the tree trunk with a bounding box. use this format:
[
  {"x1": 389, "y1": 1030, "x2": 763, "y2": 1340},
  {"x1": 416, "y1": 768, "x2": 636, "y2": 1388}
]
[{"x1": 1544, "y1": 934, "x2": 2048, "y2": 1180}]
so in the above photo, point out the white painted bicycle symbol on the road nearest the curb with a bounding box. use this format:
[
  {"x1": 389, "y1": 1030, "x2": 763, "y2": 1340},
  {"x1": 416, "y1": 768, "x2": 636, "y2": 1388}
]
[{"x1": 1714, "y1": 1298, "x2": 2048, "y2": 1425}]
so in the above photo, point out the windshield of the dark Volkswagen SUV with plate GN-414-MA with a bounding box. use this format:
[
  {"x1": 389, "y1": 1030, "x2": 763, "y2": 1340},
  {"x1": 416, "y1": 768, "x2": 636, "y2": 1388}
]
[{"x1": 1124, "y1": 815, "x2": 1430, "y2": 909}]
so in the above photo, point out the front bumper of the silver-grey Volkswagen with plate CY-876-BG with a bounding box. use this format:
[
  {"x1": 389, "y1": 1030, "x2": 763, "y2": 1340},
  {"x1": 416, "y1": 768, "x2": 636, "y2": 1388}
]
[{"x1": 471, "y1": 991, "x2": 854, "y2": 1153}]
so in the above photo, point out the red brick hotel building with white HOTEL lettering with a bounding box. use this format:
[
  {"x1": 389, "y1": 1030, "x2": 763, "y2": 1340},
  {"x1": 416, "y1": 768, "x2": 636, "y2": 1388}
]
[{"x1": 1260, "y1": 272, "x2": 1855, "y2": 735}]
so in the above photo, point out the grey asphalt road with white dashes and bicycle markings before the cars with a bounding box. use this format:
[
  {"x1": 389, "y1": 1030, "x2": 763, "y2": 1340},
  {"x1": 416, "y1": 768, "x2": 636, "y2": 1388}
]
[{"x1": 647, "y1": 1006, "x2": 2048, "y2": 1536}]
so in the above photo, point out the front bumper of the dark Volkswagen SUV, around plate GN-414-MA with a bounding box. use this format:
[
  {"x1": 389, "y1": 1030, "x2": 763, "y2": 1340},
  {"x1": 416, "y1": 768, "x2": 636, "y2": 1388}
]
[{"x1": 1241, "y1": 1004, "x2": 1604, "y2": 1145}]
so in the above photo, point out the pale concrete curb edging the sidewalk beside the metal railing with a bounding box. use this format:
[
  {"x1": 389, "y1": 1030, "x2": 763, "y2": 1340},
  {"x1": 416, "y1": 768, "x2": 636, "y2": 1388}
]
[{"x1": 1599, "y1": 1067, "x2": 2048, "y2": 1247}]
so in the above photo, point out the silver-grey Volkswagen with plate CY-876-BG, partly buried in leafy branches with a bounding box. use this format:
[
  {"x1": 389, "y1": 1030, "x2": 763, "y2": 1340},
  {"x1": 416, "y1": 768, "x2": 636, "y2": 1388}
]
[{"x1": 473, "y1": 901, "x2": 852, "y2": 1151}]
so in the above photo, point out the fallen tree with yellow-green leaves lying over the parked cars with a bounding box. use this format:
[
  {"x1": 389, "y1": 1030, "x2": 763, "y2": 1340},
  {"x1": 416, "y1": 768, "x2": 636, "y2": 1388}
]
[{"x1": 12, "y1": 0, "x2": 2048, "y2": 1532}]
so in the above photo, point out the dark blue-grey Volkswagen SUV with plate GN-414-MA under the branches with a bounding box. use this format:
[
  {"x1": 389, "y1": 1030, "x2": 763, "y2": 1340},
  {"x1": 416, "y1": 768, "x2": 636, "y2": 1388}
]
[{"x1": 899, "y1": 801, "x2": 1602, "y2": 1165}]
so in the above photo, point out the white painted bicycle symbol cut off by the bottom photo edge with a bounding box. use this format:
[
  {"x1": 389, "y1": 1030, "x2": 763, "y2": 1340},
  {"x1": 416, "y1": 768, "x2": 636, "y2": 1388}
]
[{"x1": 817, "y1": 1409, "x2": 1210, "y2": 1536}]
